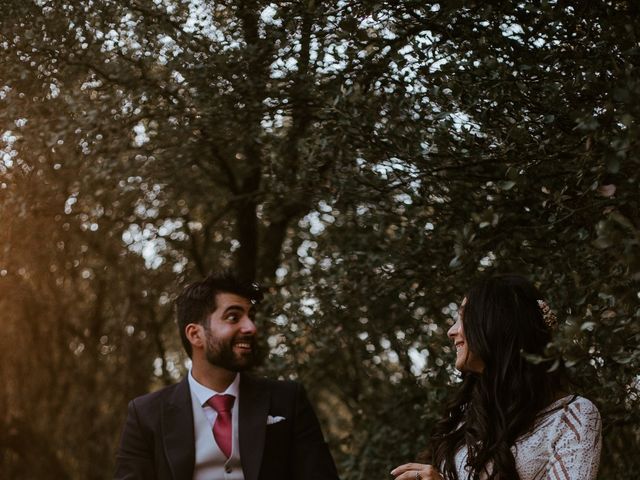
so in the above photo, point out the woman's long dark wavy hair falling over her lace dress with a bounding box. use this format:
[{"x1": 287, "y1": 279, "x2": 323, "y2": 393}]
[{"x1": 425, "y1": 275, "x2": 564, "y2": 480}]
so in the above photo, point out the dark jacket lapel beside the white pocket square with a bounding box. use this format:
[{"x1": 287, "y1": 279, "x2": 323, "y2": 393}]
[{"x1": 238, "y1": 375, "x2": 270, "y2": 480}]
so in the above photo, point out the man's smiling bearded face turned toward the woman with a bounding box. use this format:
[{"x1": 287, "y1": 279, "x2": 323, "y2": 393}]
[{"x1": 204, "y1": 293, "x2": 256, "y2": 372}]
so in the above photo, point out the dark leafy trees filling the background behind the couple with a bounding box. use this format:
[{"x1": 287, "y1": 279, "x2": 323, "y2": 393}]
[{"x1": 0, "y1": 0, "x2": 640, "y2": 480}]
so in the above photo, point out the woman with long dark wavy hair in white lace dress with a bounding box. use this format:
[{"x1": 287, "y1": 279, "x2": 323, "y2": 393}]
[{"x1": 391, "y1": 275, "x2": 601, "y2": 480}]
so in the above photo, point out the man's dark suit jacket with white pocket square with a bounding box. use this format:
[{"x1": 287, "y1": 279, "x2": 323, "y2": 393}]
[{"x1": 114, "y1": 374, "x2": 338, "y2": 480}]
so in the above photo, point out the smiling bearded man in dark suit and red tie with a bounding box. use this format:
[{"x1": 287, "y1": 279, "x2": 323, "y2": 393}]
[{"x1": 115, "y1": 274, "x2": 338, "y2": 480}]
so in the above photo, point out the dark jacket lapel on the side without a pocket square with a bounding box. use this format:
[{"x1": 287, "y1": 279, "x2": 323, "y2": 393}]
[{"x1": 162, "y1": 378, "x2": 196, "y2": 480}]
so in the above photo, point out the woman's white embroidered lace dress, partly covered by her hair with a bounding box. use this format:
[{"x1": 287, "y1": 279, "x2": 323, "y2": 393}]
[{"x1": 455, "y1": 395, "x2": 602, "y2": 480}]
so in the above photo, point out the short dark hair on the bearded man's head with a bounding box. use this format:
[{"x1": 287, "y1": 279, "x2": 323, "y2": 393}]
[{"x1": 176, "y1": 271, "x2": 262, "y2": 358}]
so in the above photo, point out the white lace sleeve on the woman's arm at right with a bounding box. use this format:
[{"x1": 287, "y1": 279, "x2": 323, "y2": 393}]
[{"x1": 546, "y1": 397, "x2": 602, "y2": 480}]
